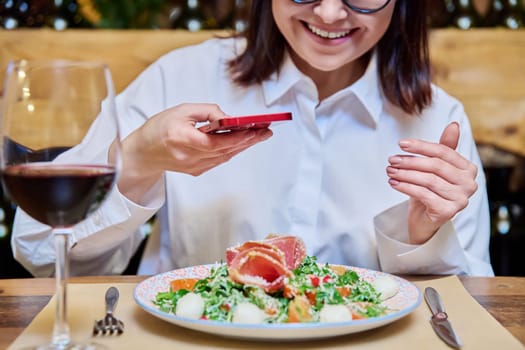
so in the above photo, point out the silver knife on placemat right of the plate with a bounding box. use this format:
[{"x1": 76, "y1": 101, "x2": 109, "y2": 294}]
[{"x1": 425, "y1": 287, "x2": 463, "y2": 349}]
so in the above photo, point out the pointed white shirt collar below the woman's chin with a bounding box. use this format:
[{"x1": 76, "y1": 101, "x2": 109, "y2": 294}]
[{"x1": 262, "y1": 48, "x2": 384, "y2": 125}]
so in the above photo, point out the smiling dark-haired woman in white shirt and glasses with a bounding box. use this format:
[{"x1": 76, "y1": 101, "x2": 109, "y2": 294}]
[{"x1": 13, "y1": 0, "x2": 493, "y2": 276}]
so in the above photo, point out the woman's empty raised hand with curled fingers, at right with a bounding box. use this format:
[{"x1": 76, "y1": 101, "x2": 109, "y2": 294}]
[{"x1": 387, "y1": 123, "x2": 478, "y2": 244}]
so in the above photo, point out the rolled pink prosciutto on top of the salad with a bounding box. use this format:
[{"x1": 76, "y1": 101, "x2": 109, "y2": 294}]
[{"x1": 226, "y1": 235, "x2": 306, "y2": 293}]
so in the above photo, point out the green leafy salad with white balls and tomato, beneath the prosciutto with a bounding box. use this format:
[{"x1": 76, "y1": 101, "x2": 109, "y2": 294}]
[{"x1": 153, "y1": 256, "x2": 395, "y2": 324}]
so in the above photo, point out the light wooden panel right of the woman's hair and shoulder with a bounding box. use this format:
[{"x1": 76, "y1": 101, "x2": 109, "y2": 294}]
[{"x1": 430, "y1": 29, "x2": 525, "y2": 155}]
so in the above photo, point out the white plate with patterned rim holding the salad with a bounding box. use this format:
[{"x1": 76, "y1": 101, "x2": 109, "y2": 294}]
[{"x1": 133, "y1": 265, "x2": 422, "y2": 341}]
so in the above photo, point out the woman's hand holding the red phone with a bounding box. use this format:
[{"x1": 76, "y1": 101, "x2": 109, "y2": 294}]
[{"x1": 113, "y1": 104, "x2": 272, "y2": 203}]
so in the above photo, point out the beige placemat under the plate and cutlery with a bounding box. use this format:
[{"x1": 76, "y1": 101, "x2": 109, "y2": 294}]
[{"x1": 9, "y1": 276, "x2": 525, "y2": 350}]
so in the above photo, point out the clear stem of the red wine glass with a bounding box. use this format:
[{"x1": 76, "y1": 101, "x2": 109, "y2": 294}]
[{"x1": 52, "y1": 228, "x2": 72, "y2": 347}]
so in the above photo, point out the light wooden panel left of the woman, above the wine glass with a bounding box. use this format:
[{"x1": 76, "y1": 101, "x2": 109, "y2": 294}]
[{"x1": 0, "y1": 29, "x2": 215, "y2": 91}]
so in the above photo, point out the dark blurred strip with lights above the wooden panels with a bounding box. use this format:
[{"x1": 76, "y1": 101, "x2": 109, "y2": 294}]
[{"x1": 0, "y1": 0, "x2": 524, "y2": 31}]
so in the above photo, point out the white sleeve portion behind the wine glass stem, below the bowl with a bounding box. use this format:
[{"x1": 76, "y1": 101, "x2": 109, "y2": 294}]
[{"x1": 11, "y1": 166, "x2": 164, "y2": 277}]
